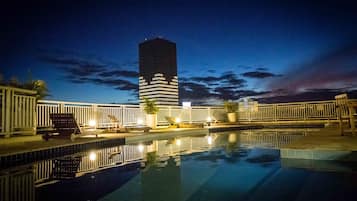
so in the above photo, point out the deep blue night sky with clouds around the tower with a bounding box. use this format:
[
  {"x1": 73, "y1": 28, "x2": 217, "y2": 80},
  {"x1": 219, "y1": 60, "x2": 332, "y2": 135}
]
[{"x1": 0, "y1": 0, "x2": 357, "y2": 105}]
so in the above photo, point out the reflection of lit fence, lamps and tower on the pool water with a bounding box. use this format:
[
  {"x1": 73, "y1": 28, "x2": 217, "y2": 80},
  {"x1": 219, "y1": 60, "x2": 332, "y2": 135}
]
[{"x1": 0, "y1": 130, "x2": 312, "y2": 201}]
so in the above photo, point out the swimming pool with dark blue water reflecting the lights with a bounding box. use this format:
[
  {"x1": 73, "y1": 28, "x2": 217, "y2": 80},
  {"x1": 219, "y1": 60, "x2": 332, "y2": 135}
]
[{"x1": 0, "y1": 130, "x2": 357, "y2": 201}]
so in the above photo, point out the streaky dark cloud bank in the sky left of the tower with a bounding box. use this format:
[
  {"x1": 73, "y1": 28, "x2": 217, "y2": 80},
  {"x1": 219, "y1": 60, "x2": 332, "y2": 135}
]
[{"x1": 38, "y1": 51, "x2": 138, "y2": 94}]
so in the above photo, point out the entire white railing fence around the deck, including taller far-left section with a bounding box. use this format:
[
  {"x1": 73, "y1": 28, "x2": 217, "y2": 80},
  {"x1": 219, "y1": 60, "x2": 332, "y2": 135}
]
[{"x1": 0, "y1": 86, "x2": 356, "y2": 137}]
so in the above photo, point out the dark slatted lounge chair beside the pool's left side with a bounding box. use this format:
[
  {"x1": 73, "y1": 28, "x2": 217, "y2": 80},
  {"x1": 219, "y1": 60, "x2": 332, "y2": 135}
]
[{"x1": 45, "y1": 113, "x2": 98, "y2": 140}]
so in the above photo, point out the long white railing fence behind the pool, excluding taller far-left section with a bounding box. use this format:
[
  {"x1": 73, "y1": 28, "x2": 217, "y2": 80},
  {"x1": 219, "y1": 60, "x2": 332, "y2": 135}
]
[{"x1": 37, "y1": 100, "x2": 337, "y2": 127}]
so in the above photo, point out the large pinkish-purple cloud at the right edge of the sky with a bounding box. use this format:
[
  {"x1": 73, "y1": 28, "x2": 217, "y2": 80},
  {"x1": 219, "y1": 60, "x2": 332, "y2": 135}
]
[{"x1": 268, "y1": 43, "x2": 357, "y2": 93}]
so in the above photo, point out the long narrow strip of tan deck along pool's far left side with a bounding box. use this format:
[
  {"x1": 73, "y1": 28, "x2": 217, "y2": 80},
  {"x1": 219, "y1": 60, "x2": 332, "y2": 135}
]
[{"x1": 0, "y1": 124, "x2": 257, "y2": 157}]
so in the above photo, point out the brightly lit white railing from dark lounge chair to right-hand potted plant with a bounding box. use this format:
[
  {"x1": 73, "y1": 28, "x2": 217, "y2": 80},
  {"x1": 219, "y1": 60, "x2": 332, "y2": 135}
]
[{"x1": 37, "y1": 100, "x2": 224, "y2": 128}]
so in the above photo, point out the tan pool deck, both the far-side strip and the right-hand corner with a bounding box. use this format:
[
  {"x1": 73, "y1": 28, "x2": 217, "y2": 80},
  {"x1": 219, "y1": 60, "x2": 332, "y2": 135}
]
[{"x1": 0, "y1": 124, "x2": 357, "y2": 166}]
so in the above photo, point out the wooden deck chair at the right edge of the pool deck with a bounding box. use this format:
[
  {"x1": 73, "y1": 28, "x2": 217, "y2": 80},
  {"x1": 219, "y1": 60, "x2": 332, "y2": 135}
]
[{"x1": 335, "y1": 94, "x2": 355, "y2": 135}]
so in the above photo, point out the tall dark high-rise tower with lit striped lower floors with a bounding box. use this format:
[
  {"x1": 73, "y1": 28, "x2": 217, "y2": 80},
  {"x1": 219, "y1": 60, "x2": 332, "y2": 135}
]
[{"x1": 139, "y1": 38, "x2": 179, "y2": 105}]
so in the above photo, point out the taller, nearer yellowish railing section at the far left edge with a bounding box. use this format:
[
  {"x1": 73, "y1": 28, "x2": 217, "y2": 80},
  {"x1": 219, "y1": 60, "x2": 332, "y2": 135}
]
[{"x1": 0, "y1": 86, "x2": 36, "y2": 137}]
